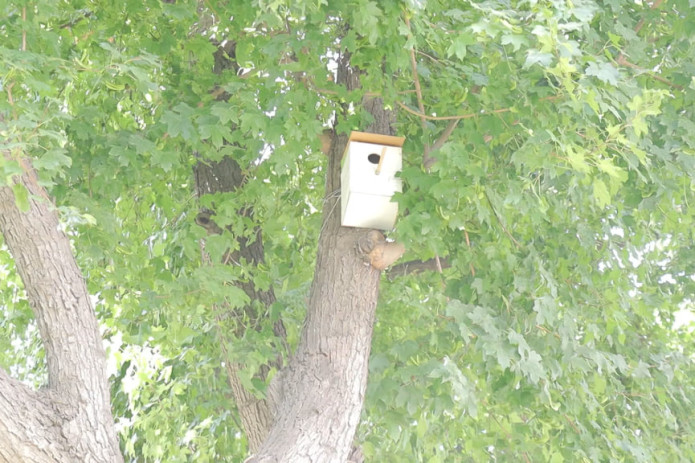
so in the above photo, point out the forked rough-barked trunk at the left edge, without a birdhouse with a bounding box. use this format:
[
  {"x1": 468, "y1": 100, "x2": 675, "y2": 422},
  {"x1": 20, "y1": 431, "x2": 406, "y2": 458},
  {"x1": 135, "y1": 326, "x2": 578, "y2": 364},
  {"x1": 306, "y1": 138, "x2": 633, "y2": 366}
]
[{"x1": 0, "y1": 160, "x2": 123, "y2": 463}]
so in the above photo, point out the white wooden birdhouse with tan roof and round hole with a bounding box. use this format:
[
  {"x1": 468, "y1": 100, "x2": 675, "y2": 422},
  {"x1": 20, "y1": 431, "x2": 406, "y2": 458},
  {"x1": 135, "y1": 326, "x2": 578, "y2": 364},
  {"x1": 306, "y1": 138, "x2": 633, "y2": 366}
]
[{"x1": 340, "y1": 132, "x2": 405, "y2": 230}]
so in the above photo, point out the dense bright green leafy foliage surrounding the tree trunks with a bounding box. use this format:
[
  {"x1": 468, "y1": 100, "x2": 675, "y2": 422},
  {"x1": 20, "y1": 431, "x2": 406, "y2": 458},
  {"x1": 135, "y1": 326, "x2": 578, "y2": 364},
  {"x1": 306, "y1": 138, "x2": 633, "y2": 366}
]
[{"x1": 0, "y1": 0, "x2": 695, "y2": 462}]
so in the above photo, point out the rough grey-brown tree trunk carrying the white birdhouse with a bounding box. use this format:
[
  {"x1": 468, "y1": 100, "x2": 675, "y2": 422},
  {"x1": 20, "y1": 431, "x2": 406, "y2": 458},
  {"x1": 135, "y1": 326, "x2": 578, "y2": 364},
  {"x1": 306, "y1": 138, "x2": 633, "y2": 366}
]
[{"x1": 249, "y1": 50, "x2": 395, "y2": 463}]
